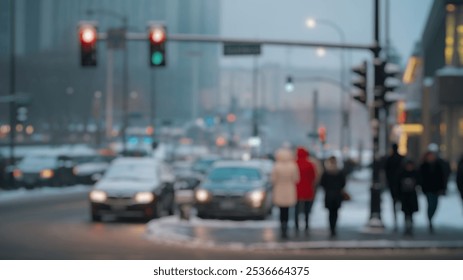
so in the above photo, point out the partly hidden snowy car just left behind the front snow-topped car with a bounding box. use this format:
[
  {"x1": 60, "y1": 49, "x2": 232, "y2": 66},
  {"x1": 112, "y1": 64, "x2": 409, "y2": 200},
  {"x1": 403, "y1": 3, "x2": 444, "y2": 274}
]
[{"x1": 72, "y1": 155, "x2": 115, "y2": 185}]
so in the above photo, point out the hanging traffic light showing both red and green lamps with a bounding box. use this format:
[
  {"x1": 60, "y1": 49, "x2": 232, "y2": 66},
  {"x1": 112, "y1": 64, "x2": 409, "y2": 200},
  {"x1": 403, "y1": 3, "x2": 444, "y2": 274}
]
[{"x1": 148, "y1": 24, "x2": 167, "y2": 67}]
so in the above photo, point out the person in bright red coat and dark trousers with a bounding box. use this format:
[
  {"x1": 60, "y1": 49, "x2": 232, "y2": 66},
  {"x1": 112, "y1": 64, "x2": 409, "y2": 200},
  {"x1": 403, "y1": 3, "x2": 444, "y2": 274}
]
[{"x1": 294, "y1": 147, "x2": 317, "y2": 234}]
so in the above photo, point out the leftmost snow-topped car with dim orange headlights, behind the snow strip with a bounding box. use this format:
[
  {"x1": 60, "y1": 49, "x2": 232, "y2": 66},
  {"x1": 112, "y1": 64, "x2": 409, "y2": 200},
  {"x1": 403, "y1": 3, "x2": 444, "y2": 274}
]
[{"x1": 13, "y1": 153, "x2": 73, "y2": 189}]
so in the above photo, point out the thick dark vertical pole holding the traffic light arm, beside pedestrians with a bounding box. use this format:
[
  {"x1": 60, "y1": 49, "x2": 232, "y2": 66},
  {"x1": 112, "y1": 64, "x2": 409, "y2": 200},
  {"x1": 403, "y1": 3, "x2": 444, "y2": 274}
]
[{"x1": 368, "y1": 0, "x2": 384, "y2": 230}]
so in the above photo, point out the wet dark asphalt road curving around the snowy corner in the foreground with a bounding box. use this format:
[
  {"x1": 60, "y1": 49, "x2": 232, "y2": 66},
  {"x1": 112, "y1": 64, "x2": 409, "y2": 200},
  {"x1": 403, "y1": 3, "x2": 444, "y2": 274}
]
[{"x1": 0, "y1": 192, "x2": 463, "y2": 260}]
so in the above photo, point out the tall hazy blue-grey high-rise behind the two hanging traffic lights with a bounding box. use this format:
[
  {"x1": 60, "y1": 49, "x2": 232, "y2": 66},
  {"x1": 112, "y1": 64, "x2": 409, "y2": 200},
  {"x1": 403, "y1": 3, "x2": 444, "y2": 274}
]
[{"x1": 0, "y1": 0, "x2": 220, "y2": 136}]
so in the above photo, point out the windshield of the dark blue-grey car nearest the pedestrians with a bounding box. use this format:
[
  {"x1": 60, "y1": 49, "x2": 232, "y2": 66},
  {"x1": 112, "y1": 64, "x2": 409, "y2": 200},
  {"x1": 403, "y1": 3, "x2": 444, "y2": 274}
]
[{"x1": 208, "y1": 167, "x2": 261, "y2": 182}]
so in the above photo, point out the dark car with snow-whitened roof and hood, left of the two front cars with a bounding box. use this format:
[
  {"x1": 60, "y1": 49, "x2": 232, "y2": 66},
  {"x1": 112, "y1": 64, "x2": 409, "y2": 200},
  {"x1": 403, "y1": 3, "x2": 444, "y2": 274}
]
[{"x1": 89, "y1": 157, "x2": 175, "y2": 222}]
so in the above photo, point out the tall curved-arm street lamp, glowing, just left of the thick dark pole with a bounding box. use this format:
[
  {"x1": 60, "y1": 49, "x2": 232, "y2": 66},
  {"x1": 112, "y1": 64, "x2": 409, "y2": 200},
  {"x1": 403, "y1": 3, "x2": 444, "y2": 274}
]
[{"x1": 306, "y1": 18, "x2": 350, "y2": 152}]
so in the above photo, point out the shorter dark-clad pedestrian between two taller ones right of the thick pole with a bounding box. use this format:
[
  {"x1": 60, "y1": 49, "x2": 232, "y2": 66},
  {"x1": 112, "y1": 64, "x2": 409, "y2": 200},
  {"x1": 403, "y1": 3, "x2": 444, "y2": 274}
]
[{"x1": 397, "y1": 159, "x2": 419, "y2": 235}]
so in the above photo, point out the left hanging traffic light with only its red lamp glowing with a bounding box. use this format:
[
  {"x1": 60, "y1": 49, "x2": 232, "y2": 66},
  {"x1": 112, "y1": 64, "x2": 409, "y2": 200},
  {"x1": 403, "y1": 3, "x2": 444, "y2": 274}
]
[{"x1": 79, "y1": 23, "x2": 98, "y2": 67}]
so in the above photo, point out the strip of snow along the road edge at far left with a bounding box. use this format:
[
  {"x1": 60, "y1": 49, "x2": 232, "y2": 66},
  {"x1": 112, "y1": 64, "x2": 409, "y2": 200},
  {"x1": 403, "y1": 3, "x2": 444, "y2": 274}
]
[{"x1": 0, "y1": 185, "x2": 89, "y2": 203}]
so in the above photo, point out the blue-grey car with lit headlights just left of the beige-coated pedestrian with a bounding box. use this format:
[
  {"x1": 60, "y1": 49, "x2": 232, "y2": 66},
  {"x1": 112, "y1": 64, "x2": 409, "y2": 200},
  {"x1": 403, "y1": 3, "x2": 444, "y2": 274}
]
[{"x1": 195, "y1": 161, "x2": 272, "y2": 219}]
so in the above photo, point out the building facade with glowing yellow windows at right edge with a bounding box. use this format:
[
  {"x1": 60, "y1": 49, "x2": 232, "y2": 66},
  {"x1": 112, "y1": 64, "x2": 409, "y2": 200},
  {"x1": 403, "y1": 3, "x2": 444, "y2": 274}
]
[{"x1": 404, "y1": 0, "x2": 463, "y2": 164}]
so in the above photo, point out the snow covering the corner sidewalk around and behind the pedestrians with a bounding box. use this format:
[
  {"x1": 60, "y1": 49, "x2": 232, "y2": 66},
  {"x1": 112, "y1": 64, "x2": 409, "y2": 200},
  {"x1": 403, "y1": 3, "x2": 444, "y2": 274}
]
[{"x1": 146, "y1": 170, "x2": 463, "y2": 250}]
